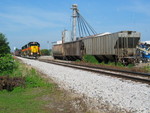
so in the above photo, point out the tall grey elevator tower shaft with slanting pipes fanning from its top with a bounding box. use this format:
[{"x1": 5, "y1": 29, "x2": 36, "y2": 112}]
[{"x1": 71, "y1": 4, "x2": 78, "y2": 41}]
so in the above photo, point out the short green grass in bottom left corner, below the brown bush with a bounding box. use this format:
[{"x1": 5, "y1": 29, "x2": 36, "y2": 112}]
[{"x1": 0, "y1": 88, "x2": 51, "y2": 113}]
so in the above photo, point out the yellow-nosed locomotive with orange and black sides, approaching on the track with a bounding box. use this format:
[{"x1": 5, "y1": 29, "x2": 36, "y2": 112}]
[{"x1": 21, "y1": 42, "x2": 40, "y2": 58}]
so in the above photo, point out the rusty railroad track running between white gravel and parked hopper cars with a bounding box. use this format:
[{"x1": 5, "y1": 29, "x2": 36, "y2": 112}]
[{"x1": 39, "y1": 59, "x2": 150, "y2": 84}]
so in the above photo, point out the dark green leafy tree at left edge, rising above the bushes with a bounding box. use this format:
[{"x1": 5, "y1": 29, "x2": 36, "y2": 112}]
[{"x1": 0, "y1": 33, "x2": 10, "y2": 55}]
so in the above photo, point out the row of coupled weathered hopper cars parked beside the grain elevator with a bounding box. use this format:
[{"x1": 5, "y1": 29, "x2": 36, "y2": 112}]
[{"x1": 52, "y1": 31, "x2": 140, "y2": 63}]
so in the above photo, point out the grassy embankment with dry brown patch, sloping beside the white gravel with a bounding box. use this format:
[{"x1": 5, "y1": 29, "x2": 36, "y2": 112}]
[{"x1": 0, "y1": 59, "x2": 83, "y2": 113}]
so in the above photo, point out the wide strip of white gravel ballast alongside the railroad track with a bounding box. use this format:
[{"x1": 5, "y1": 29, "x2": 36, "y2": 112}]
[{"x1": 19, "y1": 58, "x2": 150, "y2": 113}]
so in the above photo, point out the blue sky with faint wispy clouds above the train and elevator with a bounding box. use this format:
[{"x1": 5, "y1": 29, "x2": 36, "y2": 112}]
[{"x1": 0, "y1": 0, "x2": 150, "y2": 51}]
